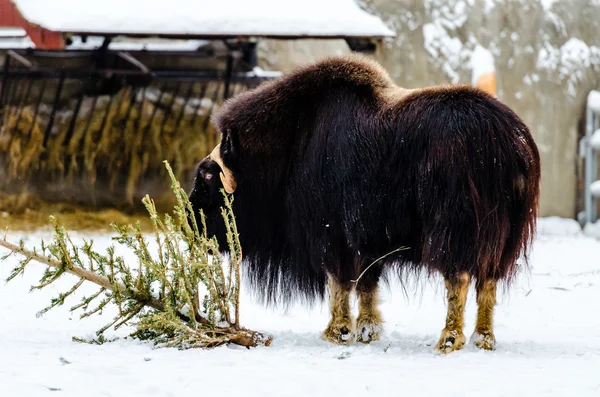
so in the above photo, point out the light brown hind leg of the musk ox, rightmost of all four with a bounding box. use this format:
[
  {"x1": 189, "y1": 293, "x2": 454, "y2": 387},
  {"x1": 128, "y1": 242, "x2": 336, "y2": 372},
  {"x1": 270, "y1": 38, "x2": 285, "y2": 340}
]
[{"x1": 471, "y1": 279, "x2": 497, "y2": 350}]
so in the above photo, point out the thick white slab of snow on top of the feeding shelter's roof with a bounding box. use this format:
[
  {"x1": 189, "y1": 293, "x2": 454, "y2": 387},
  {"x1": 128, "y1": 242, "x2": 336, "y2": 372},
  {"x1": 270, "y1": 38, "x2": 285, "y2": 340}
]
[{"x1": 12, "y1": 0, "x2": 394, "y2": 37}]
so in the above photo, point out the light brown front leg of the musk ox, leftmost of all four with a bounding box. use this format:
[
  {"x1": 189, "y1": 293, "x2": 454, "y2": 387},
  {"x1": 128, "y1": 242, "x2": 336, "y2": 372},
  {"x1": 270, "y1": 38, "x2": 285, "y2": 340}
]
[{"x1": 323, "y1": 277, "x2": 354, "y2": 344}]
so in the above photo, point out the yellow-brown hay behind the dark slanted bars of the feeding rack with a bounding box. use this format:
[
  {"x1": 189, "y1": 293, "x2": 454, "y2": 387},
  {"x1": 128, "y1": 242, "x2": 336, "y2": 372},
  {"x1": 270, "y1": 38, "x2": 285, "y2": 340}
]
[{"x1": 0, "y1": 84, "x2": 222, "y2": 211}]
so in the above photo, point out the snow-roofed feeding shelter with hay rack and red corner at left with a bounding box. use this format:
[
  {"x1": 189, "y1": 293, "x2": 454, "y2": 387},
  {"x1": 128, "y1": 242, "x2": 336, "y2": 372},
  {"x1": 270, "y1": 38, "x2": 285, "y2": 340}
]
[{"x1": 0, "y1": 0, "x2": 394, "y2": 208}]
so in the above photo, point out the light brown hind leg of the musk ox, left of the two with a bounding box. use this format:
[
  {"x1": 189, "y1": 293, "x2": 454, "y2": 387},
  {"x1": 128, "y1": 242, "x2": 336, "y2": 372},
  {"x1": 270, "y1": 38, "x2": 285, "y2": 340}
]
[{"x1": 435, "y1": 273, "x2": 471, "y2": 353}]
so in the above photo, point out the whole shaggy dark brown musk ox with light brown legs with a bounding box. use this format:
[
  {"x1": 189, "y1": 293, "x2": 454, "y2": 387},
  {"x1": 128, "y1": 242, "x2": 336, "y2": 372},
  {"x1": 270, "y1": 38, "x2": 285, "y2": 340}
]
[{"x1": 189, "y1": 55, "x2": 540, "y2": 353}]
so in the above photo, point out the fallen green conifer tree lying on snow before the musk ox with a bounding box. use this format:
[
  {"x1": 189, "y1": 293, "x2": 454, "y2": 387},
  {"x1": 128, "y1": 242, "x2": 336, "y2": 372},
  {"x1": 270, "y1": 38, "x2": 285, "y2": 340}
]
[{"x1": 0, "y1": 161, "x2": 271, "y2": 349}]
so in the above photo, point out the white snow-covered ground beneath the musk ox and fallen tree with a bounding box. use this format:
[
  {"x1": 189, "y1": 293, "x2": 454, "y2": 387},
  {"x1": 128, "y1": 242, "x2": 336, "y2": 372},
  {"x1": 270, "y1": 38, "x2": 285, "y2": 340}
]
[{"x1": 0, "y1": 219, "x2": 600, "y2": 397}]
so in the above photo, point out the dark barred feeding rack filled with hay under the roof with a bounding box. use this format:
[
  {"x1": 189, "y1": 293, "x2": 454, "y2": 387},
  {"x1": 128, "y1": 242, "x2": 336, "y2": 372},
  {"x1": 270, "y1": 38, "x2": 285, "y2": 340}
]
[{"x1": 0, "y1": 45, "x2": 277, "y2": 210}]
